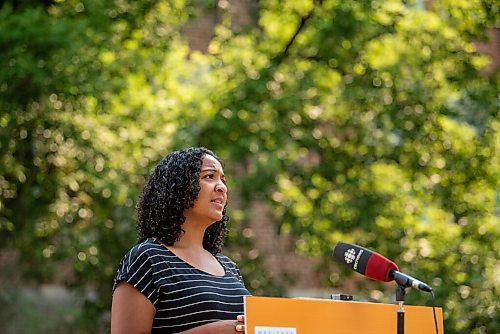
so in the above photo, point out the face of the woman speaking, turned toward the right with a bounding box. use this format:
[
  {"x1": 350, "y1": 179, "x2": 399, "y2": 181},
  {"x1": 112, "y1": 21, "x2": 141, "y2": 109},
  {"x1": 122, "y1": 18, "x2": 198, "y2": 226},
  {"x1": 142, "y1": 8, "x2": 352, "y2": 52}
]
[{"x1": 184, "y1": 154, "x2": 227, "y2": 224}]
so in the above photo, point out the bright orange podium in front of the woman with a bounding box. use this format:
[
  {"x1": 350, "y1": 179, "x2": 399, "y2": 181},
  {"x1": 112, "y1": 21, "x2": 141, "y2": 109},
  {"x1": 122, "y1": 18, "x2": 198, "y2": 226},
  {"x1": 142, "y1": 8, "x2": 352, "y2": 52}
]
[{"x1": 245, "y1": 296, "x2": 443, "y2": 334}]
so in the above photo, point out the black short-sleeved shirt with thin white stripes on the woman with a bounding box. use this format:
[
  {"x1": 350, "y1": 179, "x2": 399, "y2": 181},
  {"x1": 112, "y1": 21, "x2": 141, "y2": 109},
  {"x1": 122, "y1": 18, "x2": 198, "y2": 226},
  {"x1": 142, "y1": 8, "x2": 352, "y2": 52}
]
[{"x1": 113, "y1": 239, "x2": 250, "y2": 333}]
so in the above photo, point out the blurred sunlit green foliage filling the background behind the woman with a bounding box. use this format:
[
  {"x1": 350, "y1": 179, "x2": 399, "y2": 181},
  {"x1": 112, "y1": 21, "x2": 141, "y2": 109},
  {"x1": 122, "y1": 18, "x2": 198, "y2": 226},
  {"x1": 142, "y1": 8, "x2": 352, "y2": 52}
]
[{"x1": 0, "y1": 0, "x2": 500, "y2": 334}]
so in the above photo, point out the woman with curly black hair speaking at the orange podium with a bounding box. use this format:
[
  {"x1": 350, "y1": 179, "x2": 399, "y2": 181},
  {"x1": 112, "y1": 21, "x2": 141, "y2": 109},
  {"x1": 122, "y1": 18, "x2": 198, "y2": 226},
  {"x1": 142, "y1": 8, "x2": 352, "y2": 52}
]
[{"x1": 111, "y1": 148, "x2": 249, "y2": 334}]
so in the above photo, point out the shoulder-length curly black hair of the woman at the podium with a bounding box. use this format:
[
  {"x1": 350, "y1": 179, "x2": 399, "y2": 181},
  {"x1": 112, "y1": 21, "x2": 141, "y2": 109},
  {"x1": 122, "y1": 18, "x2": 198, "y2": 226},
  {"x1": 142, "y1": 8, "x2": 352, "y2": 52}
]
[{"x1": 137, "y1": 147, "x2": 229, "y2": 255}]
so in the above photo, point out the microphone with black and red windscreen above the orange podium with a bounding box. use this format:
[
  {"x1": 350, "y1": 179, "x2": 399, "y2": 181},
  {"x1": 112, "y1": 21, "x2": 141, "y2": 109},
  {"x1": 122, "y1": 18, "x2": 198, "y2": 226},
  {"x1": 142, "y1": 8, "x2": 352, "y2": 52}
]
[{"x1": 333, "y1": 242, "x2": 432, "y2": 292}]
